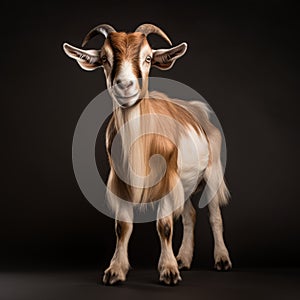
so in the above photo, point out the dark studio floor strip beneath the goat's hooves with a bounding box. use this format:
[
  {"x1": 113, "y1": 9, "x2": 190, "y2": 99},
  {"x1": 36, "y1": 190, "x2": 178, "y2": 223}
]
[{"x1": 0, "y1": 269, "x2": 300, "y2": 300}]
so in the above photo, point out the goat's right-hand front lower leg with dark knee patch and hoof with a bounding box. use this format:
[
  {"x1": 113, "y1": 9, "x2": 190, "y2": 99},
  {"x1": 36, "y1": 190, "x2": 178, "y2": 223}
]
[{"x1": 157, "y1": 215, "x2": 181, "y2": 285}]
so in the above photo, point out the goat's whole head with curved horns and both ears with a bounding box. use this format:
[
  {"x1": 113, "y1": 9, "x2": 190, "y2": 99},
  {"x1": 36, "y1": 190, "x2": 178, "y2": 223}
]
[{"x1": 63, "y1": 24, "x2": 187, "y2": 108}]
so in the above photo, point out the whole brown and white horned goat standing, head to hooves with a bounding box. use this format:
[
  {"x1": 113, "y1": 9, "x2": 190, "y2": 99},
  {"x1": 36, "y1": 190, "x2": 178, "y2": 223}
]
[{"x1": 63, "y1": 24, "x2": 231, "y2": 284}]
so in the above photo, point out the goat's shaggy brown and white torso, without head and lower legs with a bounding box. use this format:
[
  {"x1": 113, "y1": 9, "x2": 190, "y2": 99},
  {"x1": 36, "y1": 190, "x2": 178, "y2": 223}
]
[{"x1": 106, "y1": 92, "x2": 229, "y2": 215}]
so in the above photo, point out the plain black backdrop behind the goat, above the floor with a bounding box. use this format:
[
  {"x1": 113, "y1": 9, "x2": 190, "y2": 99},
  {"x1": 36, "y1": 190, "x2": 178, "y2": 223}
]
[{"x1": 0, "y1": 0, "x2": 300, "y2": 268}]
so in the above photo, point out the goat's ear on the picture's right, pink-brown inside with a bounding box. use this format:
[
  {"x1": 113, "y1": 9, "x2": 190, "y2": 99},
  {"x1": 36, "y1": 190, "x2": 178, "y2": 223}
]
[{"x1": 152, "y1": 43, "x2": 187, "y2": 70}]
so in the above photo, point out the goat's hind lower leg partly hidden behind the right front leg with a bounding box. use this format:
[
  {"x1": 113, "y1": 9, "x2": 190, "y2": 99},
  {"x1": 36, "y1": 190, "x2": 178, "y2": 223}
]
[{"x1": 176, "y1": 199, "x2": 196, "y2": 269}]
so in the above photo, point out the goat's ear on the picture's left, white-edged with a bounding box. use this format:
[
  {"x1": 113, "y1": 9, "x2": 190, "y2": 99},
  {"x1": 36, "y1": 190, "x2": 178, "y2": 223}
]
[{"x1": 63, "y1": 43, "x2": 102, "y2": 71}]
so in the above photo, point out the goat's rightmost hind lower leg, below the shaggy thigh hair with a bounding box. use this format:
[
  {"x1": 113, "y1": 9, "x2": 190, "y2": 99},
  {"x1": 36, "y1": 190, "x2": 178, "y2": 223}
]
[{"x1": 208, "y1": 197, "x2": 232, "y2": 271}]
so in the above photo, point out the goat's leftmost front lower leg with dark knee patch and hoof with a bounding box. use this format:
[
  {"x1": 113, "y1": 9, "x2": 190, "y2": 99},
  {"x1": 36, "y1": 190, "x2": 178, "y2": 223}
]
[{"x1": 103, "y1": 220, "x2": 133, "y2": 285}]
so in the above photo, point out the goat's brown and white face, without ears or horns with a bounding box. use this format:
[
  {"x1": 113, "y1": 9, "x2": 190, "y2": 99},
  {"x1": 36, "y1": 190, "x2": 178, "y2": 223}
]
[{"x1": 100, "y1": 32, "x2": 152, "y2": 107}]
